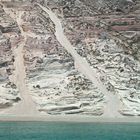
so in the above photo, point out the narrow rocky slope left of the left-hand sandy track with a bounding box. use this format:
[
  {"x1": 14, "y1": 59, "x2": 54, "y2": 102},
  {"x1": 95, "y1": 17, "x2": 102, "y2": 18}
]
[{"x1": 0, "y1": 6, "x2": 20, "y2": 109}]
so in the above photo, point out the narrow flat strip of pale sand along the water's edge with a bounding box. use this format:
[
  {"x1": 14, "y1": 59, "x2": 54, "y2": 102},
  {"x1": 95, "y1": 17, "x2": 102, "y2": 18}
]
[{"x1": 0, "y1": 115, "x2": 140, "y2": 123}]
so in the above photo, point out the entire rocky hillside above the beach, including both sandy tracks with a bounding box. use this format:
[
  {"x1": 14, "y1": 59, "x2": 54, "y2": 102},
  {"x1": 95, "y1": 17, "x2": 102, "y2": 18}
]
[{"x1": 0, "y1": 0, "x2": 140, "y2": 117}]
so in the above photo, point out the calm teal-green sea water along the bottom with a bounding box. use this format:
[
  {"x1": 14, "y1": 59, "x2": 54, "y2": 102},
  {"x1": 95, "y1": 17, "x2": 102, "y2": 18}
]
[{"x1": 0, "y1": 122, "x2": 140, "y2": 140}]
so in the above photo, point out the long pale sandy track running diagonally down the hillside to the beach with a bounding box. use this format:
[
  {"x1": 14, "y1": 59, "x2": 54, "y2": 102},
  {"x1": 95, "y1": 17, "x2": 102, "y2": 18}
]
[{"x1": 38, "y1": 4, "x2": 121, "y2": 117}]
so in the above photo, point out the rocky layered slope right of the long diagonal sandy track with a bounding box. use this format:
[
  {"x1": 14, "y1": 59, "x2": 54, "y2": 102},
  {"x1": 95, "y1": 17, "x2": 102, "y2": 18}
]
[{"x1": 44, "y1": 0, "x2": 140, "y2": 115}]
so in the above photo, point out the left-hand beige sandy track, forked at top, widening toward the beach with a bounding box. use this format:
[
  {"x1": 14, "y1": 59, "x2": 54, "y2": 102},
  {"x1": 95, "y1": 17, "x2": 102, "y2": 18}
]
[{"x1": 3, "y1": 6, "x2": 38, "y2": 115}]
